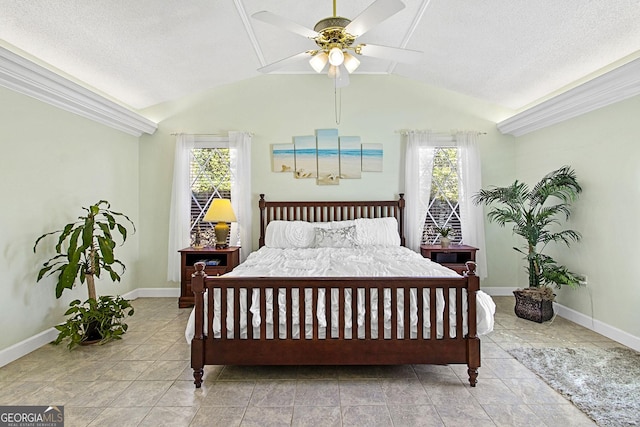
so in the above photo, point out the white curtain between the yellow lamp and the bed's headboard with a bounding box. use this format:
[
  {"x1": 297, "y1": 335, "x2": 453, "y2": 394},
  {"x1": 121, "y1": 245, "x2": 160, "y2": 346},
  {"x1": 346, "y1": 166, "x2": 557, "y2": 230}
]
[{"x1": 229, "y1": 132, "x2": 253, "y2": 262}]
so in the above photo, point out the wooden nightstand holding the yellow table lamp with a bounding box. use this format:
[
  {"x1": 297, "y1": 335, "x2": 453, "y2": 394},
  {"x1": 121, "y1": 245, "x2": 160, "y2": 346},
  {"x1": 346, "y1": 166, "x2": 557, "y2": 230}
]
[{"x1": 178, "y1": 246, "x2": 240, "y2": 308}]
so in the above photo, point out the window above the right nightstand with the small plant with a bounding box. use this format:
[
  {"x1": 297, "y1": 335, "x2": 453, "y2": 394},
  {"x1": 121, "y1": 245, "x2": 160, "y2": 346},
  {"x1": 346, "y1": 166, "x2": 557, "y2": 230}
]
[{"x1": 422, "y1": 147, "x2": 462, "y2": 244}]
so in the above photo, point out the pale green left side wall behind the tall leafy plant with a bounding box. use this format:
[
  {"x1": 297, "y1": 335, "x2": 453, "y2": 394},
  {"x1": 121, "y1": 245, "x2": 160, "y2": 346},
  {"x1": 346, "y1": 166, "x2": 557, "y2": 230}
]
[{"x1": 0, "y1": 87, "x2": 139, "y2": 350}]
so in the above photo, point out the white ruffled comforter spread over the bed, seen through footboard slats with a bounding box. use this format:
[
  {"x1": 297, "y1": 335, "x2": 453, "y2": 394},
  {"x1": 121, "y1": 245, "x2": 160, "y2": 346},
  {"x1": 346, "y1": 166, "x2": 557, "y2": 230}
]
[{"x1": 185, "y1": 246, "x2": 495, "y2": 343}]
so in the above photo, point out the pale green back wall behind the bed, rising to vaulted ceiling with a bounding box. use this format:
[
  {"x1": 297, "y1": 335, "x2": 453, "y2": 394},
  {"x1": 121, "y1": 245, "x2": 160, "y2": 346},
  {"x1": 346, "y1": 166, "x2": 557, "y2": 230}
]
[{"x1": 140, "y1": 75, "x2": 517, "y2": 294}]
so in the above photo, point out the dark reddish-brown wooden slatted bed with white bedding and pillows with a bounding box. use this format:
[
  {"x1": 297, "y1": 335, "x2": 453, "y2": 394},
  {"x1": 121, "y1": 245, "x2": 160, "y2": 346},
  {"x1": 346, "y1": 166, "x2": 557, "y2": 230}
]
[{"x1": 186, "y1": 194, "x2": 495, "y2": 387}]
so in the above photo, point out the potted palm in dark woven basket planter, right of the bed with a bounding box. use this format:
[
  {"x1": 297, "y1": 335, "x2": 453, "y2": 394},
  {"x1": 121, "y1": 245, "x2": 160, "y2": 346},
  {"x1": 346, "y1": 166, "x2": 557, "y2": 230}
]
[{"x1": 474, "y1": 166, "x2": 582, "y2": 322}]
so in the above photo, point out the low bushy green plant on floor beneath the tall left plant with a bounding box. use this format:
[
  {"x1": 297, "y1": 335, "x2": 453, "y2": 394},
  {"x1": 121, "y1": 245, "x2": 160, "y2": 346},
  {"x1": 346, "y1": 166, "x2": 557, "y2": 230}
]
[{"x1": 53, "y1": 296, "x2": 134, "y2": 350}]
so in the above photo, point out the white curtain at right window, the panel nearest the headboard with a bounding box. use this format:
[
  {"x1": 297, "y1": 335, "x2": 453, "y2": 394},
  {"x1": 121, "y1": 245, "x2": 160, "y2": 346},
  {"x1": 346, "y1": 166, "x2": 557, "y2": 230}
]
[{"x1": 404, "y1": 131, "x2": 436, "y2": 252}]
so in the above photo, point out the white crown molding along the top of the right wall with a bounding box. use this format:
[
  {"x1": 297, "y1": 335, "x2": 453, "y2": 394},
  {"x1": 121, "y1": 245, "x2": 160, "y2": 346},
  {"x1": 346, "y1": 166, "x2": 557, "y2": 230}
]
[{"x1": 497, "y1": 59, "x2": 640, "y2": 136}]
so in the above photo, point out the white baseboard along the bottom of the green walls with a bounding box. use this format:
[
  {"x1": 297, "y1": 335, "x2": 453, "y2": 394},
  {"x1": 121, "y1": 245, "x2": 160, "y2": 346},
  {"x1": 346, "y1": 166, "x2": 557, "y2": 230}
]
[{"x1": 0, "y1": 287, "x2": 640, "y2": 367}]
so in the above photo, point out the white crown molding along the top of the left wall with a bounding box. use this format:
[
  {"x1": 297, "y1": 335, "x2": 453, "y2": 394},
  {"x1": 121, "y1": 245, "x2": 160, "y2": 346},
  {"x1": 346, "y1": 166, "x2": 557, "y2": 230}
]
[{"x1": 0, "y1": 46, "x2": 158, "y2": 136}]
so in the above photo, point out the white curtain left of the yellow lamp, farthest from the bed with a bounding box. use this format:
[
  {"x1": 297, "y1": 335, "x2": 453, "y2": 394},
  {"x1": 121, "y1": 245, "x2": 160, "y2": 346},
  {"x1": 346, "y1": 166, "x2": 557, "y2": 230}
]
[{"x1": 167, "y1": 134, "x2": 194, "y2": 282}]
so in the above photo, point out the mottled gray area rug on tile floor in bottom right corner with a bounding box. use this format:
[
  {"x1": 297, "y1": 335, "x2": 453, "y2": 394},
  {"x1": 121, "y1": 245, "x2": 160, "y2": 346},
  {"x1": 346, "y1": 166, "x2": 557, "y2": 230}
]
[{"x1": 509, "y1": 348, "x2": 640, "y2": 426}]
